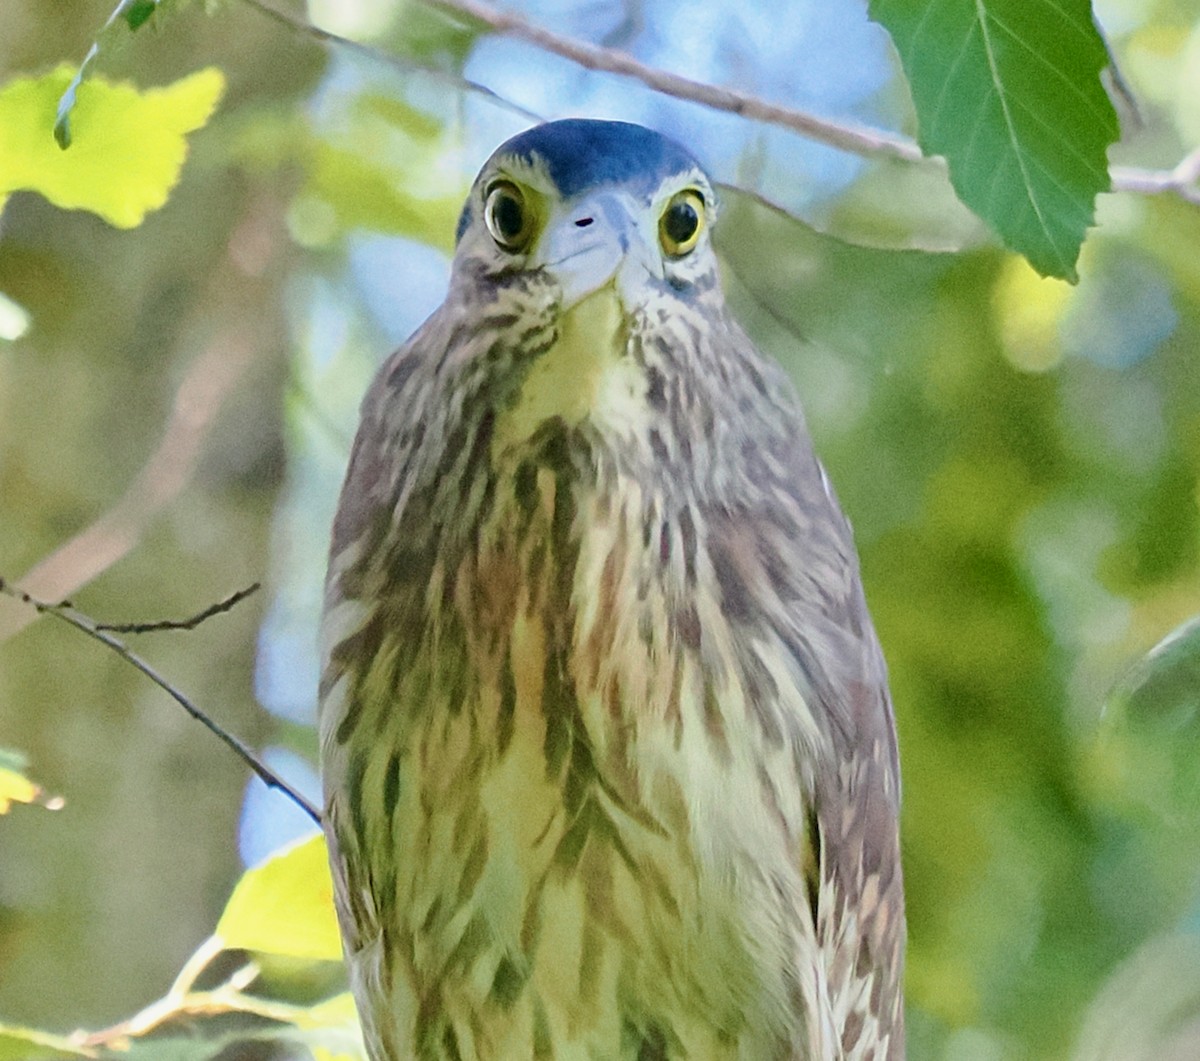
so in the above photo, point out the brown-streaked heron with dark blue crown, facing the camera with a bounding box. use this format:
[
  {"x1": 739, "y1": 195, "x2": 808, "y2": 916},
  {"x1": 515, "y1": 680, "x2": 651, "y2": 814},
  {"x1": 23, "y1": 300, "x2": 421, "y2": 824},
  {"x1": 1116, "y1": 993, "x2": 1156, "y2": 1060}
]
[{"x1": 320, "y1": 120, "x2": 905, "y2": 1061}]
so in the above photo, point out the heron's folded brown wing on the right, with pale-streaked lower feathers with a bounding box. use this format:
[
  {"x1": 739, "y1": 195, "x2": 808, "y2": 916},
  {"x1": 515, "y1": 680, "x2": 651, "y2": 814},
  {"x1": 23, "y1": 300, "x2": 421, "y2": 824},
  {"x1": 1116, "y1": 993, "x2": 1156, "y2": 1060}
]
[{"x1": 704, "y1": 350, "x2": 905, "y2": 1061}]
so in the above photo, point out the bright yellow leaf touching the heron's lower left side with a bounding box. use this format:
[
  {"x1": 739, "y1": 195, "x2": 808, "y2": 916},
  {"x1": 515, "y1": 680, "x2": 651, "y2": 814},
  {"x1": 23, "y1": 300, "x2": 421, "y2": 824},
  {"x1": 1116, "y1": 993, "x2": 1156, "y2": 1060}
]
[{"x1": 216, "y1": 835, "x2": 342, "y2": 961}]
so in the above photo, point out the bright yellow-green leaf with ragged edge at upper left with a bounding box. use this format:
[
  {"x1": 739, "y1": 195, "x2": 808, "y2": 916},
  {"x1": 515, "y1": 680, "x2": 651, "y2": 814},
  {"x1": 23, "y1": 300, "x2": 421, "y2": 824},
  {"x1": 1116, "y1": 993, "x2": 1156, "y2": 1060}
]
[{"x1": 0, "y1": 66, "x2": 224, "y2": 228}]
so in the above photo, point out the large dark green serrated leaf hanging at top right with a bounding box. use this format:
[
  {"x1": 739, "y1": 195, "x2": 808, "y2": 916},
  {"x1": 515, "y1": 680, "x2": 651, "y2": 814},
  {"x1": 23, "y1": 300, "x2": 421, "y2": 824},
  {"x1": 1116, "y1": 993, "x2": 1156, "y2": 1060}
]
[{"x1": 870, "y1": 0, "x2": 1120, "y2": 281}]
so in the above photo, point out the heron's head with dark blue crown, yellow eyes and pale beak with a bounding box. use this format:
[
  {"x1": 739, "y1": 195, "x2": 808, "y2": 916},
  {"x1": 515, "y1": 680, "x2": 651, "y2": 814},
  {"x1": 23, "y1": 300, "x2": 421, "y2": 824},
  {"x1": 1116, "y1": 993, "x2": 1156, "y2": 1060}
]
[{"x1": 456, "y1": 119, "x2": 716, "y2": 311}]
